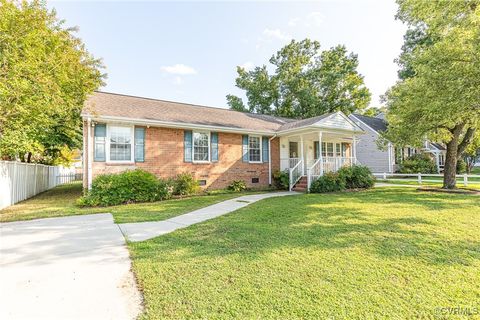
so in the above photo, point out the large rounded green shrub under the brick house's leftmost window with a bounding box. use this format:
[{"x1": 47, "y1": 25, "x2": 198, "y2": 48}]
[{"x1": 78, "y1": 169, "x2": 170, "y2": 206}]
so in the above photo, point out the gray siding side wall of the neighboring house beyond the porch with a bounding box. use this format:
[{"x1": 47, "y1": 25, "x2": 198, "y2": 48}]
[{"x1": 350, "y1": 117, "x2": 393, "y2": 172}]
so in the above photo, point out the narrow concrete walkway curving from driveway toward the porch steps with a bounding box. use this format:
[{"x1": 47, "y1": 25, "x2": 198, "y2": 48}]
[{"x1": 118, "y1": 192, "x2": 300, "y2": 242}]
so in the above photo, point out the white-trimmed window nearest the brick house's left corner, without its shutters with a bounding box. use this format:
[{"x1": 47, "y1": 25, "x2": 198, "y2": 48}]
[{"x1": 108, "y1": 126, "x2": 133, "y2": 161}]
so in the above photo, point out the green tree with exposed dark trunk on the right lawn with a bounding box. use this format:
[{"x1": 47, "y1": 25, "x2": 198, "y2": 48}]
[{"x1": 386, "y1": 0, "x2": 480, "y2": 188}]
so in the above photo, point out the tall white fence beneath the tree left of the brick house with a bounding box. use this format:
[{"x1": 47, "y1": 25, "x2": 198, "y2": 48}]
[{"x1": 0, "y1": 161, "x2": 76, "y2": 210}]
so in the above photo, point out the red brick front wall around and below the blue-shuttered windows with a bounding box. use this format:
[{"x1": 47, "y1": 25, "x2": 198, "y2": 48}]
[{"x1": 86, "y1": 127, "x2": 280, "y2": 189}]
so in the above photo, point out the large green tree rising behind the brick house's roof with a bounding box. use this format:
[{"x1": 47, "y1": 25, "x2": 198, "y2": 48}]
[{"x1": 227, "y1": 39, "x2": 370, "y2": 118}]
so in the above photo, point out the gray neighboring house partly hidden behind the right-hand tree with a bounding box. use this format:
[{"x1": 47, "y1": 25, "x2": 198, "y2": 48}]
[{"x1": 349, "y1": 113, "x2": 446, "y2": 173}]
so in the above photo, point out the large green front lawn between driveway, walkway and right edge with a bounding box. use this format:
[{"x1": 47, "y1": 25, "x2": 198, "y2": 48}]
[{"x1": 129, "y1": 188, "x2": 480, "y2": 319}]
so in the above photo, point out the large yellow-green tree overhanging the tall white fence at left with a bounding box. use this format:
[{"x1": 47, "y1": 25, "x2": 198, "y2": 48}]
[{"x1": 0, "y1": 0, "x2": 103, "y2": 163}]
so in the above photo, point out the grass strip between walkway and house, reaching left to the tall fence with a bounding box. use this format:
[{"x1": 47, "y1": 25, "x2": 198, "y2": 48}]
[{"x1": 0, "y1": 183, "x2": 260, "y2": 223}]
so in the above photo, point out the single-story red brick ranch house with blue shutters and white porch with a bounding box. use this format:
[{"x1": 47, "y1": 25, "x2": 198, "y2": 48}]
[{"x1": 82, "y1": 92, "x2": 364, "y2": 189}]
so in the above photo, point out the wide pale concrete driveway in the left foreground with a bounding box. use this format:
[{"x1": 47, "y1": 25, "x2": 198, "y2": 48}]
[{"x1": 0, "y1": 214, "x2": 141, "y2": 320}]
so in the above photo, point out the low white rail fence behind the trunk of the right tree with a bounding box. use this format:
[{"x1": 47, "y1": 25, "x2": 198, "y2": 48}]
[{"x1": 373, "y1": 172, "x2": 480, "y2": 187}]
